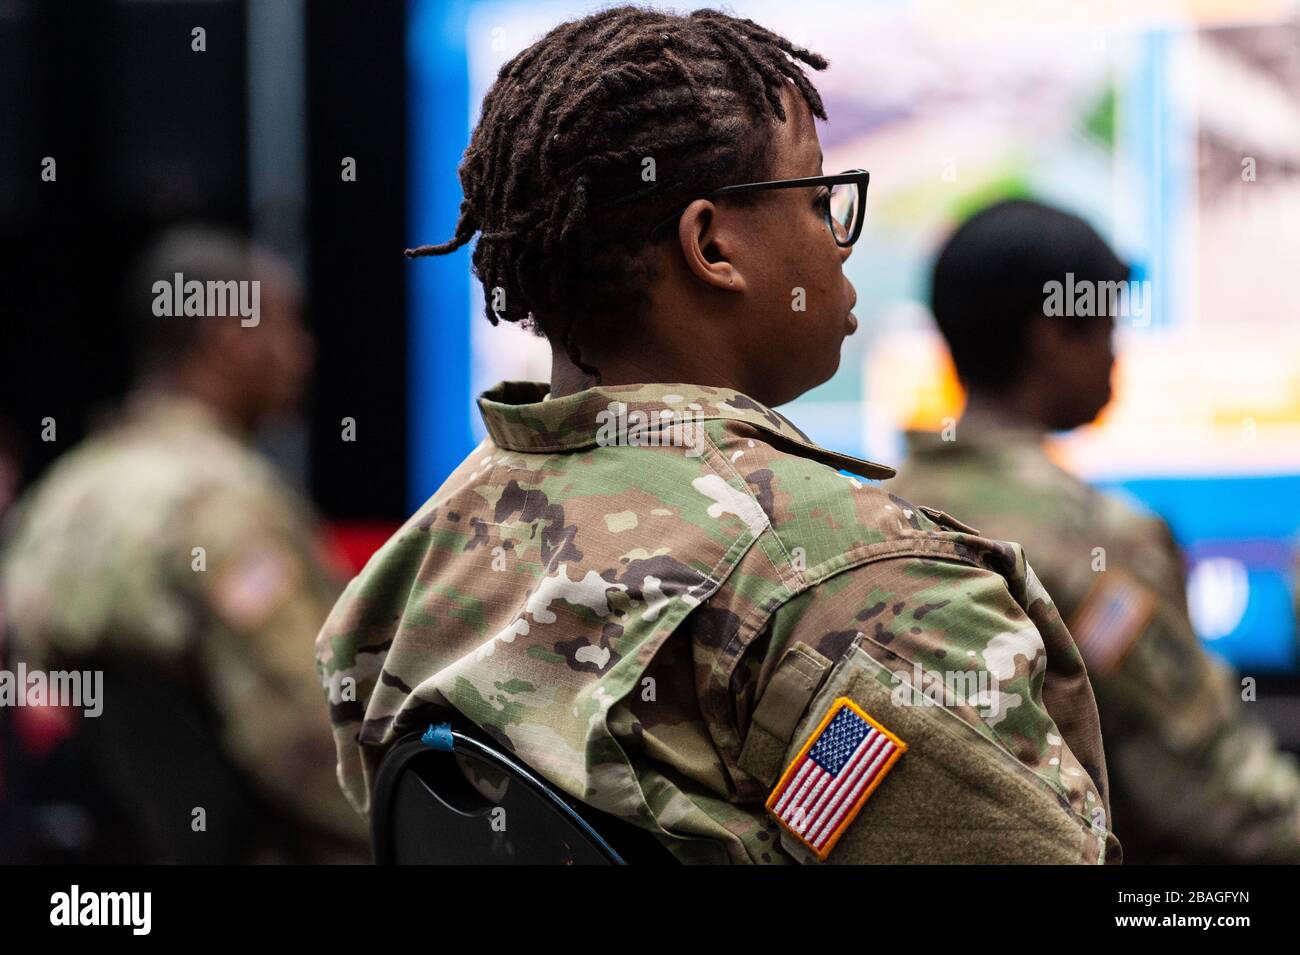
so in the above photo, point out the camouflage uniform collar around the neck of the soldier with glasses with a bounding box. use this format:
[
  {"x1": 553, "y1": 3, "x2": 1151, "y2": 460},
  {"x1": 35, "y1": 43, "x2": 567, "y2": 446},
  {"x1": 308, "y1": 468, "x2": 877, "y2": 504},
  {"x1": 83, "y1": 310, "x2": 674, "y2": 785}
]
[{"x1": 478, "y1": 381, "x2": 894, "y2": 481}]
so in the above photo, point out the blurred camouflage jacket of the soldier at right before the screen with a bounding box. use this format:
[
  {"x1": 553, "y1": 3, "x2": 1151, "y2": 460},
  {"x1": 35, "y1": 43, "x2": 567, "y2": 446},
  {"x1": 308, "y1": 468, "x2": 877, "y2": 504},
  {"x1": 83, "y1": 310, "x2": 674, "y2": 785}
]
[{"x1": 893, "y1": 416, "x2": 1300, "y2": 861}]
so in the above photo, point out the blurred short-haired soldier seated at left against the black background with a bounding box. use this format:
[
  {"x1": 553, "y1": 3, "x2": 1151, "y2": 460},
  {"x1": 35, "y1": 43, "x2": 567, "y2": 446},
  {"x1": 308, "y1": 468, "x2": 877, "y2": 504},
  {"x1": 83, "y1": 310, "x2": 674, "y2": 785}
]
[{"x1": 3, "y1": 229, "x2": 367, "y2": 861}]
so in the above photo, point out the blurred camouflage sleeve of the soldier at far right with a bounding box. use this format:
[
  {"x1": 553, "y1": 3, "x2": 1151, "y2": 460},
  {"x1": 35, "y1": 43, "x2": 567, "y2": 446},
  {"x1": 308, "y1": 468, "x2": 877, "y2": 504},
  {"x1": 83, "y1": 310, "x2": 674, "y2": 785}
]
[{"x1": 1073, "y1": 563, "x2": 1300, "y2": 863}]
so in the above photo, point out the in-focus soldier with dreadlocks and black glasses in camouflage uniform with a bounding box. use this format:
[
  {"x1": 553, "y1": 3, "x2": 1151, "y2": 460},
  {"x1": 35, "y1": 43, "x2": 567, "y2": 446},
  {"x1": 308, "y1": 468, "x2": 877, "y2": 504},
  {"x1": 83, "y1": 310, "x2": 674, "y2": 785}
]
[{"x1": 317, "y1": 8, "x2": 1118, "y2": 864}]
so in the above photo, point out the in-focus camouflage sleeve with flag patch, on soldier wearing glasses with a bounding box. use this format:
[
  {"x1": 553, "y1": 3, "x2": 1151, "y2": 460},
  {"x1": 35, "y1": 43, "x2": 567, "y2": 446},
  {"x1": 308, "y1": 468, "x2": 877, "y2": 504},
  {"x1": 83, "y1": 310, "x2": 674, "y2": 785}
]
[{"x1": 755, "y1": 546, "x2": 1118, "y2": 864}]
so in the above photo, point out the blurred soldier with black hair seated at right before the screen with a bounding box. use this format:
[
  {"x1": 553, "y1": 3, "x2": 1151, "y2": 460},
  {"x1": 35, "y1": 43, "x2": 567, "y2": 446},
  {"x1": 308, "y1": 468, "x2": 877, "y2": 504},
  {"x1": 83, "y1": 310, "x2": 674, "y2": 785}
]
[{"x1": 889, "y1": 200, "x2": 1300, "y2": 863}]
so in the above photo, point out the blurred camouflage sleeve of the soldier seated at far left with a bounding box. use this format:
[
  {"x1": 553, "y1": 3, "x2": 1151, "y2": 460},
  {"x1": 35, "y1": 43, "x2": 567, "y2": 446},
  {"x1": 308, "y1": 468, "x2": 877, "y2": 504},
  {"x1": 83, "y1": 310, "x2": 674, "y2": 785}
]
[{"x1": 185, "y1": 494, "x2": 365, "y2": 859}]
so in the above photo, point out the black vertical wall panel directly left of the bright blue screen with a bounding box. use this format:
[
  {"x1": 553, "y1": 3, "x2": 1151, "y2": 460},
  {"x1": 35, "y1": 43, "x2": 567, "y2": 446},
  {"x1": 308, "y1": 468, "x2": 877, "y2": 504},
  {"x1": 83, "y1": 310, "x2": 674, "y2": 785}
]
[{"x1": 307, "y1": 0, "x2": 410, "y2": 520}]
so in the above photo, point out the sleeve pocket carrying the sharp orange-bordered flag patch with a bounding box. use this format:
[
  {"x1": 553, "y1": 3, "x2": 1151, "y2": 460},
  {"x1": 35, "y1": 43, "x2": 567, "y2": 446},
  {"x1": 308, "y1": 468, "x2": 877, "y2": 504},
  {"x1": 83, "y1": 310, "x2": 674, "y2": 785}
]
[{"x1": 767, "y1": 634, "x2": 1118, "y2": 864}]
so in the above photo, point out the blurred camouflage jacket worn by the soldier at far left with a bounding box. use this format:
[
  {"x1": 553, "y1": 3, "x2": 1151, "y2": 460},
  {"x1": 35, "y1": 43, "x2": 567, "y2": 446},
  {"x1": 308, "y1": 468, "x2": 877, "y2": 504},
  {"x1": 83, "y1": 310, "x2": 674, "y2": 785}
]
[{"x1": 3, "y1": 394, "x2": 367, "y2": 861}]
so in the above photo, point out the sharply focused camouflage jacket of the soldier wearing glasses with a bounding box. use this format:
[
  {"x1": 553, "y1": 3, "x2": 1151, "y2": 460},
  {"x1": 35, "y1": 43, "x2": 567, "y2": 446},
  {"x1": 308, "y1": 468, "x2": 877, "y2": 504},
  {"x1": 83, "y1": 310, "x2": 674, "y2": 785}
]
[{"x1": 317, "y1": 382, "x2": 1118, "y2": 863}]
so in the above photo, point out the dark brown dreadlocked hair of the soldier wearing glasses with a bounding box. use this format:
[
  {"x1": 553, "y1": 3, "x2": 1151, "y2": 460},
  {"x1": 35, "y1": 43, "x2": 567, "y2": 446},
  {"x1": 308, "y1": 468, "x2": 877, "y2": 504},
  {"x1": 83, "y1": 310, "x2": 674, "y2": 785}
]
[{"x1": 406, "y1": 6, "x2": 827, "y2": 381}]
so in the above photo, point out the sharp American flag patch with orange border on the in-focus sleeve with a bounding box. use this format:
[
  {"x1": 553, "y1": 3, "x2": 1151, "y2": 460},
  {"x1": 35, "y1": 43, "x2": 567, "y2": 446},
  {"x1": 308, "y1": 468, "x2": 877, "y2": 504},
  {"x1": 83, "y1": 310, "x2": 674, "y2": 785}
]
[{"x1": 767, "y1": 696, "x2": 907, "y2": 859}]
